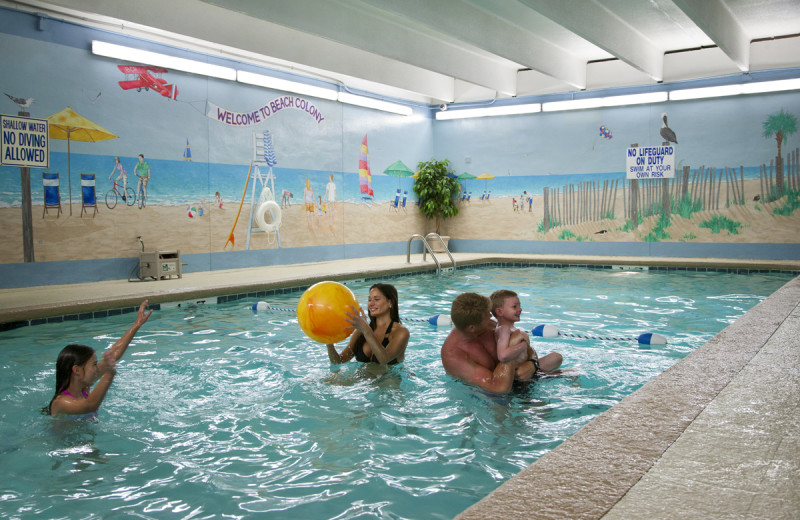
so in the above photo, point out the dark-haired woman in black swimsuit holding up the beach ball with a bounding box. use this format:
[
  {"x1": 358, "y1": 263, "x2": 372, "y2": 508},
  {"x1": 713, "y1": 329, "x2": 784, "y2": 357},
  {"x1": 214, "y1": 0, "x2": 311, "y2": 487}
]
[{"x1": 328, "y1": 283, "x2": 409, "y2": 365}]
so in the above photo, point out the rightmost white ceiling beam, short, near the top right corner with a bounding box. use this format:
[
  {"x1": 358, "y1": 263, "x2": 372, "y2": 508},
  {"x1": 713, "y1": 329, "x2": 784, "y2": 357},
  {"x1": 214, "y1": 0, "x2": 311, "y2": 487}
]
[{"x1": 673, "y1": 0, "x2": 750, "y2": 71}]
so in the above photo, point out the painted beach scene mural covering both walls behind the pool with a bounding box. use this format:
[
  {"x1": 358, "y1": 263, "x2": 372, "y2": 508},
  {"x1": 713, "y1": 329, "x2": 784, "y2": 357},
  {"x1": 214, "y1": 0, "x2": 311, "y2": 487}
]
[{"x1": 0, "y1": 10, "x2": 800, "y2": 272}]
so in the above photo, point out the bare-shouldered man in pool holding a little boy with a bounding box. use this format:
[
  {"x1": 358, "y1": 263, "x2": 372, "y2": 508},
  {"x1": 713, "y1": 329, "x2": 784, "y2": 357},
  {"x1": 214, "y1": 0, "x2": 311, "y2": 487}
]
[{"x1": 441, "y1": 293, "x2": 552, "y2": 394}]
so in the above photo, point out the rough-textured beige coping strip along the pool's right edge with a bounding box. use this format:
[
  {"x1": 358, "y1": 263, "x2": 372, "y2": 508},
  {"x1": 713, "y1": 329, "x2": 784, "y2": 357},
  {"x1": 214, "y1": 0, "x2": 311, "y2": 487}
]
[{"x1": 456, "y1": 276, "x2": 800, "y2": 520}]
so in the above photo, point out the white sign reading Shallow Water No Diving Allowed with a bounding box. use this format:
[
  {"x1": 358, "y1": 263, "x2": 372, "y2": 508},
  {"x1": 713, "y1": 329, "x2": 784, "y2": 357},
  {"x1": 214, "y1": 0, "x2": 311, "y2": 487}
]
[{"x1": 0, "y1": 115, "x2": 50, "y2": 168}]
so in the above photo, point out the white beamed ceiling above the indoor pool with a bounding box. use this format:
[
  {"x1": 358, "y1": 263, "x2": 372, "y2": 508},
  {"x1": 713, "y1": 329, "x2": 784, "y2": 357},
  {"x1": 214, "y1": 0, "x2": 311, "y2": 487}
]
[{"x1": 12, "y1": 0, "x2": 800, "y2": 104}]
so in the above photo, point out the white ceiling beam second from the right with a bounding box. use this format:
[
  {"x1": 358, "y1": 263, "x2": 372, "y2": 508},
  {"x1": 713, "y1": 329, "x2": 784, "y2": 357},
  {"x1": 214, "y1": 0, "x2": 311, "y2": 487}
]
[{"x1": 519, "y1": 0, "x2": 664, "y2": 81}]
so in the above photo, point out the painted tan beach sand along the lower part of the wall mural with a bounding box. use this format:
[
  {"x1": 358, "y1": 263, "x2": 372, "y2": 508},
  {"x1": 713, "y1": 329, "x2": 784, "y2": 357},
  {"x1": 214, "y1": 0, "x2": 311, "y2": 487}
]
[{"x1": 0, "y1": 180, "x2": 800, "y2": 263}]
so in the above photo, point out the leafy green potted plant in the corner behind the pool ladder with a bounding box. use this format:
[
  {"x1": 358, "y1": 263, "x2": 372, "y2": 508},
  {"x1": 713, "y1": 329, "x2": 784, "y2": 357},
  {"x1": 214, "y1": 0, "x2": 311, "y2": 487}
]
[{"x1": 414, "y1": 159, "x2": 461, "y2": 249}]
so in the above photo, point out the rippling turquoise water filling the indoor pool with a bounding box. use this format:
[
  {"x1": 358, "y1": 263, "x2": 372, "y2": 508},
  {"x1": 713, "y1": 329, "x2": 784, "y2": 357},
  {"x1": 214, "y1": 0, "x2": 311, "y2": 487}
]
[{"x1": 0, "y1": 267, "x2": 791, "y2": 519}]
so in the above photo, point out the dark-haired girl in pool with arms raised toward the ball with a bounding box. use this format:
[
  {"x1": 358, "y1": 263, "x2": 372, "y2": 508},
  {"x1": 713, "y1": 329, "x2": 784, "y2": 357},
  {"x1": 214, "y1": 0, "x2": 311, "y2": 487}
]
[{"x1": 47, "y1": 300, "x2": 153, "y2": 415}]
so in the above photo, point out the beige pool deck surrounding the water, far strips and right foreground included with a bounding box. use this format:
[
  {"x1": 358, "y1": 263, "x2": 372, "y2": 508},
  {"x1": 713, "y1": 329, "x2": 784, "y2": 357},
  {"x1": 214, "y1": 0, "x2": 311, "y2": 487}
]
[{"x1": 0, "y1": 253, "x2": 800, "y2": 519}]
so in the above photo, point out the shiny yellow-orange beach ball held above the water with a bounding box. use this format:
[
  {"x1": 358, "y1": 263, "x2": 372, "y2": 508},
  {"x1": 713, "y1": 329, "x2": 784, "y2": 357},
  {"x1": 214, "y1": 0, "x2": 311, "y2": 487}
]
[{"x1": 297, "y1": 282, "x2": 358, "y2": 344}]
